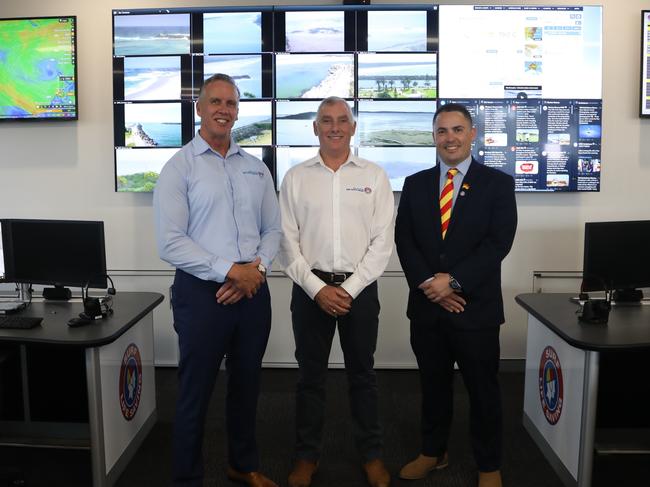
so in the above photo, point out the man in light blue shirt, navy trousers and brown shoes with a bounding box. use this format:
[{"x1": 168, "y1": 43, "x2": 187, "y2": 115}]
[{"x1": 154, "y1": 74, "x2": 281, "y2": 487}]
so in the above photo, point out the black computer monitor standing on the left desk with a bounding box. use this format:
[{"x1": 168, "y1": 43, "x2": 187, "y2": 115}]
[{"x1": 0, "y1": 219, "x2": 107, "y2": 299}]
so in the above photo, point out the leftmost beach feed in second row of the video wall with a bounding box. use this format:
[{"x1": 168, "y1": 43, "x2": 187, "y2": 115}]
[{"x1": 124, "y1": 56, "x2": 181, "y2": 100}]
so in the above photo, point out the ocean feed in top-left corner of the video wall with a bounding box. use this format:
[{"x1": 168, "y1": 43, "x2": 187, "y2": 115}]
[{"x1": 113, "y1": 14, "x2": 190, "y2": 56}]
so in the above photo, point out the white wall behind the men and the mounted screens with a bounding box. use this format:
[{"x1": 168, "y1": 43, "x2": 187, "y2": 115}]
[{"x1": 0, "y1": 0, "x2": 650, "y2": 365}]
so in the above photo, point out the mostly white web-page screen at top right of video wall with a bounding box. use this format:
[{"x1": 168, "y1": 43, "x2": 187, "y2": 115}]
[{"x1": 439, "y1": 5, "x2": 602, "y2": 99}]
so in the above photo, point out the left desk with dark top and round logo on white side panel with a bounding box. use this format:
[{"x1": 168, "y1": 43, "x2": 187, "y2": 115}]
[{"x1": 0, "y1": 292, "x2": 163, "y2": 487}]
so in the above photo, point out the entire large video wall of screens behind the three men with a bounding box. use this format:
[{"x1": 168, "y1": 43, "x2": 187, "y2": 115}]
[{"x1": 113, "y1": 4, "x2": 602, "y2": 191}]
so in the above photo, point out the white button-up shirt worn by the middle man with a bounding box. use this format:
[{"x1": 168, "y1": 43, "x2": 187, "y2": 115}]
[{"x1": 278, "y1": 153, "x2": 395, "y2": 299}]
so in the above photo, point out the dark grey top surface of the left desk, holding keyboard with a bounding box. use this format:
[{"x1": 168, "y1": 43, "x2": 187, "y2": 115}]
[{"x1": 0, "y1": 292, "x2": 163, "y2": 347}]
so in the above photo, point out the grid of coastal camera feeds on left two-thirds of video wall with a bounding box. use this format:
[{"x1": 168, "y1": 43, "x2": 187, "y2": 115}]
[{"x1": 113, "y1": 5, "x2": 438, "y2": 192}]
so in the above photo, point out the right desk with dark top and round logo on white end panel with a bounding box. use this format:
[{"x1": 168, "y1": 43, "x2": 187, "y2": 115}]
[{"x1": 515, "y1": 293, "x2": 650, "y2": 487}]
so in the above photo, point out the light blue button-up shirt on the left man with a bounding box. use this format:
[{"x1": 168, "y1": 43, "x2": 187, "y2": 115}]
[{"x1": 154, "y1": 135, "x2": 282, "y2": 282}]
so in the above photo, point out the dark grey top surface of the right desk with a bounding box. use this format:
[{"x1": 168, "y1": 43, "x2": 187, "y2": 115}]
[{"x1": 515, "y1": 293, "x2": 650, "y2": 351}]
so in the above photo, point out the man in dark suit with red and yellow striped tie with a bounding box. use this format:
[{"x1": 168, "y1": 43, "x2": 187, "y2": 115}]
[{"x1": 395, "y1": 104, "x2": 517, "y2": 487}]
